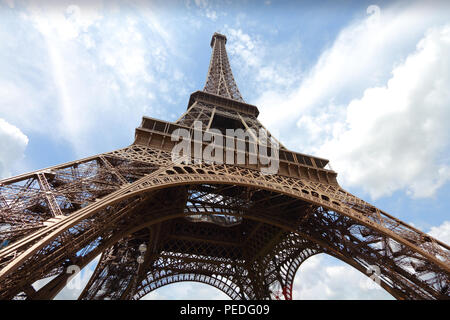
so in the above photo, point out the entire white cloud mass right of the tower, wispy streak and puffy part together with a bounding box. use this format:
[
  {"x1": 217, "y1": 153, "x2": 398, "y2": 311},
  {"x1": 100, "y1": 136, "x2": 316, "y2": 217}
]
[{"x1": 254, "y1": 3, "x2": 450, "y2": 198}]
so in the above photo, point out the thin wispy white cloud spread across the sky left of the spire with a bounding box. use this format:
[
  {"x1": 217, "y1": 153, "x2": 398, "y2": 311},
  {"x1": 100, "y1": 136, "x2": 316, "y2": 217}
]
[{"x1": 0, "y1": 1, "x2": 187, "y2": 157}]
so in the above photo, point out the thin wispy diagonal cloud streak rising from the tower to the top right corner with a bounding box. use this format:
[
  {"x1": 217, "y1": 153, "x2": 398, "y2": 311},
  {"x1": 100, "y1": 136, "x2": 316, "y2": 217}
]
[{"x1": 258, "y1": 3, "x2": 449, "y2": 129}]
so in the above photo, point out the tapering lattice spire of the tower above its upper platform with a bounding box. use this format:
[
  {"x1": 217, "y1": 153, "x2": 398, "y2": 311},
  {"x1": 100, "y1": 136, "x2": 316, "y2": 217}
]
[{"x1": 203, "y1": 32, "x2": 244, "y2": 102}]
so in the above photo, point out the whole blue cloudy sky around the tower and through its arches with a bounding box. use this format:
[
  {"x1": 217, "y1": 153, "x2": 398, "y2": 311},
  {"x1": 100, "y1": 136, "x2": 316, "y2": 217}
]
[{"x1": 0, "y1": 0, "x2": 450, "y2": 299}]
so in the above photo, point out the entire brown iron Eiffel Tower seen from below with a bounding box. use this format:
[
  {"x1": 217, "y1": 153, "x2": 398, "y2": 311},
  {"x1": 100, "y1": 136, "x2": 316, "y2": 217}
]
[{"x1": 0, "y1": 33, "x2": 450, "y2": 300}]
